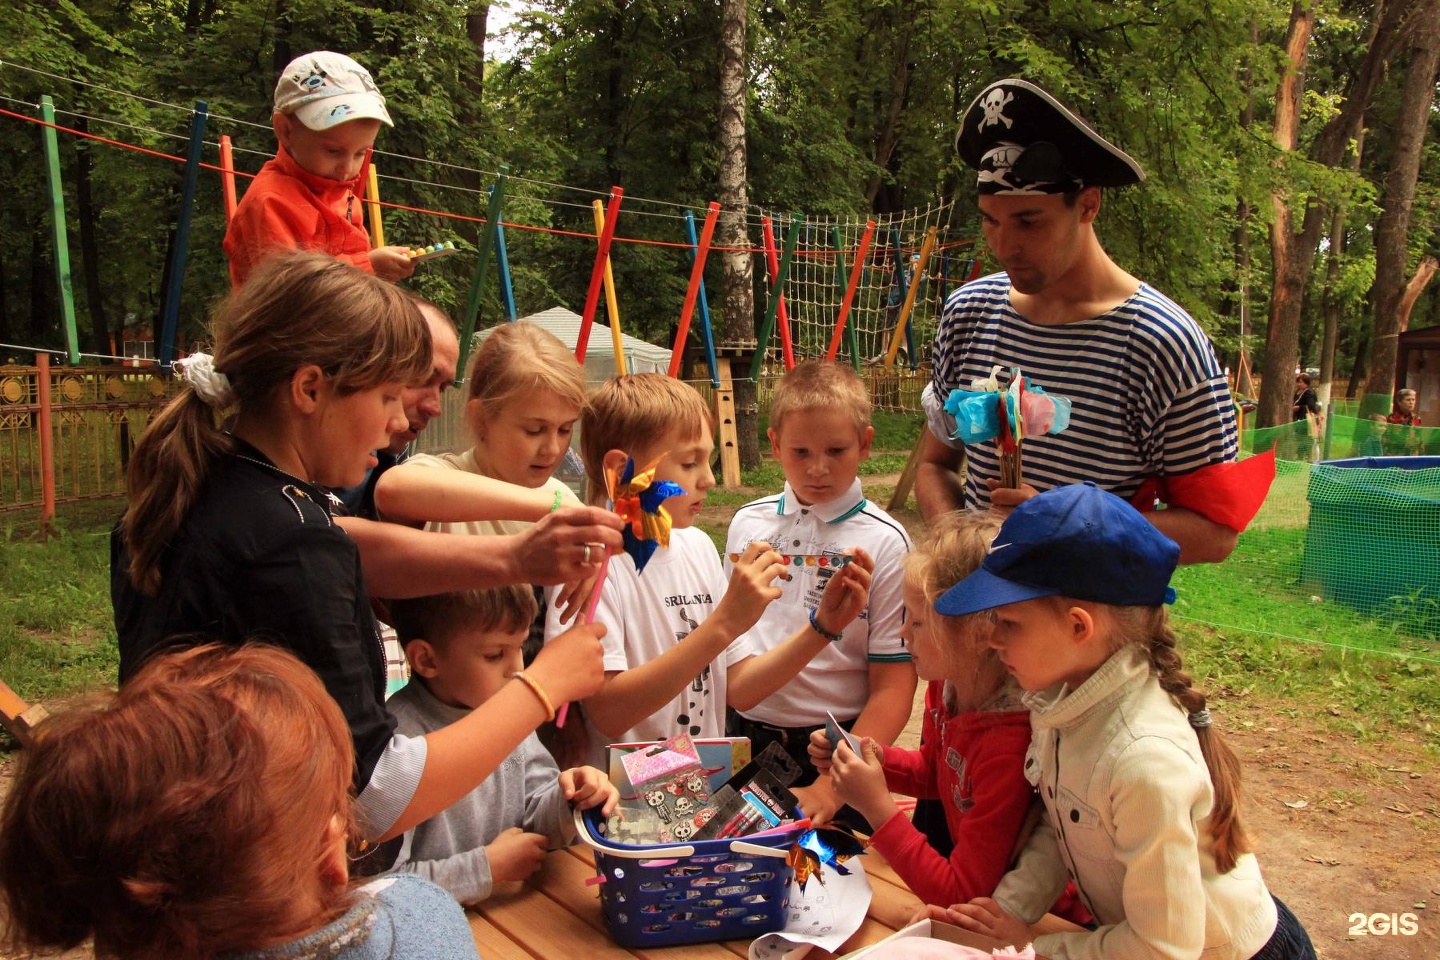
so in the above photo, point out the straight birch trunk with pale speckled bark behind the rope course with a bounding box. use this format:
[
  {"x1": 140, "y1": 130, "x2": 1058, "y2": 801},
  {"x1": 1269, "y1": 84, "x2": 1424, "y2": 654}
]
[{"x1": 716, "y1": 0, "x2": 760, "y2": 469}]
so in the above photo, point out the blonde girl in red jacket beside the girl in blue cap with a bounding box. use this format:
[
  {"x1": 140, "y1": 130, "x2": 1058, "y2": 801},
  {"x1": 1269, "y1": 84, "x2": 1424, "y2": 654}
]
[{"x1": 809, "y1": 512, "x2": 1034, "y2": 905}]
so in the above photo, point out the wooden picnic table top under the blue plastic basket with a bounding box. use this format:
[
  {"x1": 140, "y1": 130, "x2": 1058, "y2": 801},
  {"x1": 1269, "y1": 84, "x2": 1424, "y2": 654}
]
[{"x1": 468, "y1": 845, "x2": 920, "y2": 960}]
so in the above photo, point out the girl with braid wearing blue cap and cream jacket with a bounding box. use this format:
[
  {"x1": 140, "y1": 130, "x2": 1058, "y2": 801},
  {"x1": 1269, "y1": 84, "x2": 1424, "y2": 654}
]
[{"x1": 936, "y1": 484, "x2": 1315, "y2": 960}]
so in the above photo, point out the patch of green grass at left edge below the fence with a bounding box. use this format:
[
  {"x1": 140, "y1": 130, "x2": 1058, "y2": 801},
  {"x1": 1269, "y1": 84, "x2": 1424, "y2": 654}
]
[{"x1": 0, "y1": 524, "x2": 120, "y2": 702}]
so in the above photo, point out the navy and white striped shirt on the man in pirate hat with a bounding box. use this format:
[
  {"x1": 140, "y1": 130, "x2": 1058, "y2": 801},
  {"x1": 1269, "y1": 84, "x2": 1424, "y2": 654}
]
[{"x1": 924, "y1": 273, "x2": 1238, "y2": 510}]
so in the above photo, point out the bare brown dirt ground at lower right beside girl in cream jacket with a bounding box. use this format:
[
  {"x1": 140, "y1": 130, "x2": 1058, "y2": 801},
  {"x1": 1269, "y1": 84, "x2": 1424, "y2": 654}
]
[{"x1": 0, "y1": 476, "x2": 1440, "y2": 960}]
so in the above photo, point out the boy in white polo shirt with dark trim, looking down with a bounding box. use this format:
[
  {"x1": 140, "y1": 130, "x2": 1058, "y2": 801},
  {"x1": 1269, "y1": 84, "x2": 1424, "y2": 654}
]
[{"x1": 726, "y1": 360, "x2": 916, "y2": 819}]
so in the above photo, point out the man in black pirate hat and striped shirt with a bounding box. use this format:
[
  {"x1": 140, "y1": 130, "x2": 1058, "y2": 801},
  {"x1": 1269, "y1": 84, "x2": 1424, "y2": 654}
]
[{"x1": 916, "y1": 79, "x2": 1273, "y2": 563}]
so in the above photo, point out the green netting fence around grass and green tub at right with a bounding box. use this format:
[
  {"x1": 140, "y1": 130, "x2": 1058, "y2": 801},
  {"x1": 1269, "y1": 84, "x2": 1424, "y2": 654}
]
[{"x1": 1175, "y1": 403, "x2": 1440, "y2": 658}]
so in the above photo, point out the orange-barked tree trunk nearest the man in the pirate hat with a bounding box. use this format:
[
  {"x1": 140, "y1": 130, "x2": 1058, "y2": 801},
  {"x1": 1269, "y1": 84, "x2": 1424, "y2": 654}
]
[{"x1": 1257, "y1": 0, "x2": 1315, "y2": 426}]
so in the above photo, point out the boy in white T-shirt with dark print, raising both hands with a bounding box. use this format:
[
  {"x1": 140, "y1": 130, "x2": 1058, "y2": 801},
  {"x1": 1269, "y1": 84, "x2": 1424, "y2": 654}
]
[{"x1": 547, "y1": 373, "x2": 873, "y2": 766}]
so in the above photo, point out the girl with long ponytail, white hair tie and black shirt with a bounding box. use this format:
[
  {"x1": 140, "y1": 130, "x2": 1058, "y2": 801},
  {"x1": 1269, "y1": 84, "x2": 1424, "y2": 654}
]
[{"x1": 111, "y1": 252, "x2": 603, "y2": 866}]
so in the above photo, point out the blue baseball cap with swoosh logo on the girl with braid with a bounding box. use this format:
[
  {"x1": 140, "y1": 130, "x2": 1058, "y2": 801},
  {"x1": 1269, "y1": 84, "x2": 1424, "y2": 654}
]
[{"x1": 935, "y1": 484, "x2": 1179, "y2": 616}]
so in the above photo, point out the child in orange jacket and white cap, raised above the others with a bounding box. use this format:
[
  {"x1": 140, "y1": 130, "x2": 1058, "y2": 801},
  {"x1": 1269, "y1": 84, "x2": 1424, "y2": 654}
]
[{"x1": 225, "y1": 50, "x2": 415, "y2": 286}]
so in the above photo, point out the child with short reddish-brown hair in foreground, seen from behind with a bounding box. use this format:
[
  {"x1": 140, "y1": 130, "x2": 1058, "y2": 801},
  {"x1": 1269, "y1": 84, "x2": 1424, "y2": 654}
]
[{"x1": 0, "y1": 643, "x2": 475, "y2": 960}]
